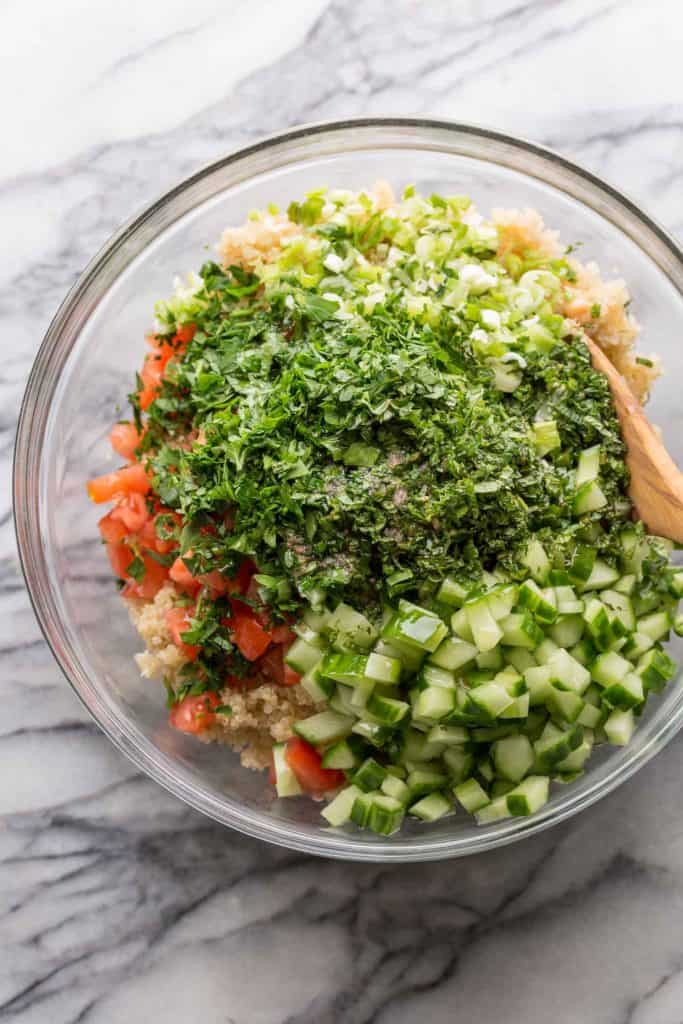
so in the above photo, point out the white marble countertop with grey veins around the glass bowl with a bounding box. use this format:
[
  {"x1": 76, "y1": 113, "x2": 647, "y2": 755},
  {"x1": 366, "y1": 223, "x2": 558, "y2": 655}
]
[{"x1": 0, "y1": 0, "x2": 683, "y2": 1024}]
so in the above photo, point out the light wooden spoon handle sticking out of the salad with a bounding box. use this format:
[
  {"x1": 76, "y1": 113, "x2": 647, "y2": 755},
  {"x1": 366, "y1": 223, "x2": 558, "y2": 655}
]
[{"x1": 584, "y1": 335, "x2": 683, "y2": 544}]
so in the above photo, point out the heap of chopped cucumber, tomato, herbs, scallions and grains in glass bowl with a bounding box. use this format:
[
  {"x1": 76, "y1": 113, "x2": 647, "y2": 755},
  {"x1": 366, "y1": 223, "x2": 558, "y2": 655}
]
[{"x1": 88, "y1": 182, "x2": 683, "y2": 835}]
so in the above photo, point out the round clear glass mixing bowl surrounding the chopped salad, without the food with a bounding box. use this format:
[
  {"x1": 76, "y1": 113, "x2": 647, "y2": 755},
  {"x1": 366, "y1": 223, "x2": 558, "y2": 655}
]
[{"x1": 14, "y1": 118, "x2": 683, "y2": 861}]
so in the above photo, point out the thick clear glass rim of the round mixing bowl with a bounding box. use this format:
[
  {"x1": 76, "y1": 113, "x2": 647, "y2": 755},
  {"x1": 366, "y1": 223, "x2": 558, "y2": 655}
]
[{"x1": 12, "y1": 117, "x2": 683, "y2": 862}]
